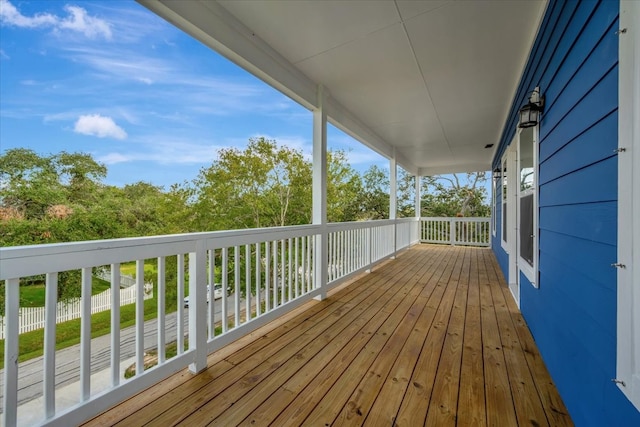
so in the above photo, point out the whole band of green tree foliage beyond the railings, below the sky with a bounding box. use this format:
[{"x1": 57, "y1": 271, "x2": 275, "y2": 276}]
[{"x1": 0, "y1": 145, "x2": 490, "y2": 310}]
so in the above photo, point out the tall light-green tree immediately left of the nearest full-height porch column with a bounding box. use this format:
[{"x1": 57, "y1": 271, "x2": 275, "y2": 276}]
[{"x1": 194, "y1": 137, "x2": 311, "y2": 230}]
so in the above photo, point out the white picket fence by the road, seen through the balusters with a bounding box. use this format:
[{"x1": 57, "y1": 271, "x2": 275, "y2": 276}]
[{"x1": 0, "y1": 287, "x2": 153, "y2": 339}]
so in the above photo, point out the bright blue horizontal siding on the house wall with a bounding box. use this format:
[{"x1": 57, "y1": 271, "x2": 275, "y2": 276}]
[{"x1": 493, "y1": 0, "x2": 640, "y2": 426}]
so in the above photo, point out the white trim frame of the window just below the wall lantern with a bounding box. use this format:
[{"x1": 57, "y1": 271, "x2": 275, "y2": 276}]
[{"x1": 516, "y1": 125, "x2": 540, "y2": 288}]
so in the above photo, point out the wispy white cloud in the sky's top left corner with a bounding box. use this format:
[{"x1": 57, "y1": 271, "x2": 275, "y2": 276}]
[{"x1": 0, "y1": 0, "x2": 111, "y2": 40}]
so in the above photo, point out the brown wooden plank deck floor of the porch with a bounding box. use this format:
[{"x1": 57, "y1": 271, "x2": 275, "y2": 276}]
[{"x1": 88, "y1": 245, "x2": 572, "y2": 426}]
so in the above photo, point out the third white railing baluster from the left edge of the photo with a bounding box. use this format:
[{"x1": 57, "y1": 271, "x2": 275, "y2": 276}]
[{"x1": 80, "y1": 267, "x2": 91, "y2": 402}]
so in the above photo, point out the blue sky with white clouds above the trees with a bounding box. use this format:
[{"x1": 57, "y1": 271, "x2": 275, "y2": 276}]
[{"x1": 0, "y1": 0, "x2": 388, "y2": 188}]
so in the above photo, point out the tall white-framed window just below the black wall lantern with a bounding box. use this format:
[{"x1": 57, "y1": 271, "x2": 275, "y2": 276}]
[{"x1": 517, "y1": 127, "x2": 538, "y2": 286}]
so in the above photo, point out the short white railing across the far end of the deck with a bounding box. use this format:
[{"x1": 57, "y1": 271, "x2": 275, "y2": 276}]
[{"x1": 420, "y1": 217, "x2": 491, "y2": 246}]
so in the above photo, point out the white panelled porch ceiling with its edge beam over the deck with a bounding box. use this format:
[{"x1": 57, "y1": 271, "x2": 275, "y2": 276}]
[{"x1": 139, "y1": 0, "x2": 546, "y2": 175}]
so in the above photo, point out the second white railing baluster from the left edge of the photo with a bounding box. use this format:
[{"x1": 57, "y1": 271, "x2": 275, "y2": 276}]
[{"x1": 43, "y1": 273, "x2": 58, "y2": 418}]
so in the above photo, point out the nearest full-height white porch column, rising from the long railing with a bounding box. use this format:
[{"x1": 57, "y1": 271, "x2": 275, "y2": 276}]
[{"x1": 312, "y1": 86, "x2": 328, "y2": 300}]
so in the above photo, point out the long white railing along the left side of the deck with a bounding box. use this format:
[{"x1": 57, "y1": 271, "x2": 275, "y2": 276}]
[{"x1": 0, "y1": 218, "x2": 419, "y2": 426}]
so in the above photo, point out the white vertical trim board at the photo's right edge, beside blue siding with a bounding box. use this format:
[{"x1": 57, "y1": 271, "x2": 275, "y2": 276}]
[{"x1": 614, "y1": 0, "x2": 640, "y2": 410}]
